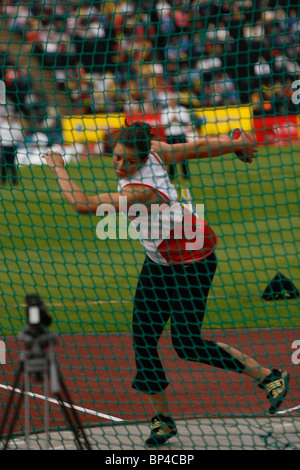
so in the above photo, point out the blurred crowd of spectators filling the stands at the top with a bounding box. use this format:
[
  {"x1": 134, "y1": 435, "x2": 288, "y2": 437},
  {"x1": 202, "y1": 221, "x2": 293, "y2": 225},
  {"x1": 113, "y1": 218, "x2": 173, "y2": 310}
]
[{"x1": 0, "y1": 0, "x2": 300, "y2": 121}]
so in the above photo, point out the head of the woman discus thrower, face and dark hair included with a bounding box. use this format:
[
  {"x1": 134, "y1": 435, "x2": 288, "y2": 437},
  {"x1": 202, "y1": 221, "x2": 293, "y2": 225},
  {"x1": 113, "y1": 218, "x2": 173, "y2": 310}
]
[{"x1": 113, "y1": 121, "x2": 153, "y2": 178}]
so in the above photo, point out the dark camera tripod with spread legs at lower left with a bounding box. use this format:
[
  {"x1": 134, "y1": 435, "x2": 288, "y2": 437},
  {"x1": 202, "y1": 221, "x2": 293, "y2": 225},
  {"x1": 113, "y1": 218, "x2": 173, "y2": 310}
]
[{"x1": 0, "y1": 328, "x2": 91, "y2": 450}]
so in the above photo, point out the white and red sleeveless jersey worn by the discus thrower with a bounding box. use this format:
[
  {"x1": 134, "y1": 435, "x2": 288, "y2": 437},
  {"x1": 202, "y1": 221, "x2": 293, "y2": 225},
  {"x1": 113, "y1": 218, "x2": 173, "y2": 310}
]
[{"x1": 118, "y1": 150, "x2": 217, "y2": 266}]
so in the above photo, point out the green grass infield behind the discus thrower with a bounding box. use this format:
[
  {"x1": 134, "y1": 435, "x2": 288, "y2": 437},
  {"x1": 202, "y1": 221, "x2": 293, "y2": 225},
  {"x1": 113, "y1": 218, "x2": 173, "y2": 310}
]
[{"x1": 0, "y1": 147, "x2": 300, "y2": 336}]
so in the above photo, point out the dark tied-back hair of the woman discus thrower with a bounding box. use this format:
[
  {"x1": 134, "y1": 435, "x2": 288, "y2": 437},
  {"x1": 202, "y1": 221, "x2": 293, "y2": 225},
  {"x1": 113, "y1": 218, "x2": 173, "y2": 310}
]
[{"x1": 113, "y1": 120, "x2": 153, "y2": 161}]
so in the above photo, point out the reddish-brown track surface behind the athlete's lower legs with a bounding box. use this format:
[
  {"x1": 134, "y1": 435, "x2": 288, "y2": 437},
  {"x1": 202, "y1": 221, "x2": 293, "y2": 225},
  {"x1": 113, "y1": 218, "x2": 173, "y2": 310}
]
[{"x1": 0, "y1": 329, "x2": 300, "y2": 431}]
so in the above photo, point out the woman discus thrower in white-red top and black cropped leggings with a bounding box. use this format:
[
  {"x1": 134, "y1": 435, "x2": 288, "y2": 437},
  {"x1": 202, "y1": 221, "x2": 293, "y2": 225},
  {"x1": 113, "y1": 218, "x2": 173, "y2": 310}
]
[{"x1": 44, "y1": 122, "x2": 289, "y2": 446}]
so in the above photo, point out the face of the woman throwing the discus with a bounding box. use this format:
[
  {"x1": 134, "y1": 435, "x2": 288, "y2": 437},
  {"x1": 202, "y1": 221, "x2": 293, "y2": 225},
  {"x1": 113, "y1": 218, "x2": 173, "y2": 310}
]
[{"x1": 113, "y1": 143, "x2": 141, "y2": 178}]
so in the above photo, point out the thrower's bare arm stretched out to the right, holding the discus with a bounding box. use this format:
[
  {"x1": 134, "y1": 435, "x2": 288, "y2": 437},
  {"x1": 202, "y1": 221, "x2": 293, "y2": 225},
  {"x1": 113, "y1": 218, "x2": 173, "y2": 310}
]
[{"x1": 151, "y1": 133, "x2": 257, "y2": 163}]
